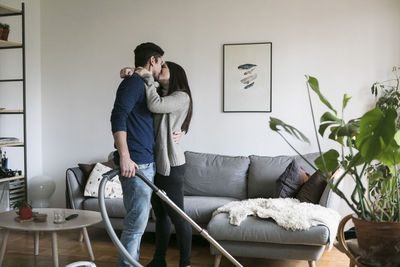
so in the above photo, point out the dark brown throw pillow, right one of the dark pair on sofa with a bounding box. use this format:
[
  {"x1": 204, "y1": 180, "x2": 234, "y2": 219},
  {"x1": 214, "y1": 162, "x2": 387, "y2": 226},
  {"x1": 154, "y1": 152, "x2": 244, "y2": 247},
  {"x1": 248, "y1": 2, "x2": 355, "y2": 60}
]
[{"x1": 296, "y1": 171, "x2": 327, "y2": 204}]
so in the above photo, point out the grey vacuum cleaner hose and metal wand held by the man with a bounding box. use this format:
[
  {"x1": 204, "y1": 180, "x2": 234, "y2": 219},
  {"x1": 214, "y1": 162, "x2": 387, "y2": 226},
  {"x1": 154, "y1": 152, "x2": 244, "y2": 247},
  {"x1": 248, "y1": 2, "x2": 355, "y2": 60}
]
[{"x1": 99, "y1": 169, "x2": 243, "y2": 267}]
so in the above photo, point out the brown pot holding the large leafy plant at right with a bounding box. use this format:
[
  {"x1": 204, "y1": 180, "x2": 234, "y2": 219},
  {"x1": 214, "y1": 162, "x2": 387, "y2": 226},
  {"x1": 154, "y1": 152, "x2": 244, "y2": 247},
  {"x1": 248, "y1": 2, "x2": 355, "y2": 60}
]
[{"x1": 352, "y1": 217, "x2": 400, "y2": 267}]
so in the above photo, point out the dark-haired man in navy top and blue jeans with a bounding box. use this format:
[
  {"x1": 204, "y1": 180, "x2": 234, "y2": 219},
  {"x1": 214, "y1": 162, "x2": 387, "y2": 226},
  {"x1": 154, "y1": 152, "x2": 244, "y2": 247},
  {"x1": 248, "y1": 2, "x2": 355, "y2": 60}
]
[{"x1": 111, "y1": 43, "x2": 164, "y2": 267}]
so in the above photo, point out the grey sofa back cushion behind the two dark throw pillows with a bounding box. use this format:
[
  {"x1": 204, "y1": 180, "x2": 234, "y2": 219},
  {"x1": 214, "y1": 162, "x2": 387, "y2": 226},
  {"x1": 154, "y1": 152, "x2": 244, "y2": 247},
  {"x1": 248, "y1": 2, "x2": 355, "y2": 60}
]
[{"x1": 248, "y1": 153, "x2": 319, "y2": 198}]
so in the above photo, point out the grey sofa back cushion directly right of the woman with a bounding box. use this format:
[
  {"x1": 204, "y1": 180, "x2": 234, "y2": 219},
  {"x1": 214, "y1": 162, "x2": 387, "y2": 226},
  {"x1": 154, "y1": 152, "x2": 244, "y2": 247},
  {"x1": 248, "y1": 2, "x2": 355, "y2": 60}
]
[{"x1": 184, "y1": 151, "x2": 250, "y2": 199}]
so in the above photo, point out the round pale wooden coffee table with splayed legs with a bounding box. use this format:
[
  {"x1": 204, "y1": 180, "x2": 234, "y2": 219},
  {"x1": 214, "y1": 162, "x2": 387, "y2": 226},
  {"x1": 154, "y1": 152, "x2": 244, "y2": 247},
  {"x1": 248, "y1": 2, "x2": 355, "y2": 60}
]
[{"x1": 0, "y1": 208, "x2": 102, "y2": 267}]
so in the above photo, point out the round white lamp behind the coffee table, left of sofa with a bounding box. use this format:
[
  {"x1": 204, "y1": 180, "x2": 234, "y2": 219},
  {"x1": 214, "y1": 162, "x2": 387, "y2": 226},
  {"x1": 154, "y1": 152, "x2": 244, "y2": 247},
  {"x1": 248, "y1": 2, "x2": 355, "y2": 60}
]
[{"x1": 29, "y1": 175, "x2": 56, "y2": 208}]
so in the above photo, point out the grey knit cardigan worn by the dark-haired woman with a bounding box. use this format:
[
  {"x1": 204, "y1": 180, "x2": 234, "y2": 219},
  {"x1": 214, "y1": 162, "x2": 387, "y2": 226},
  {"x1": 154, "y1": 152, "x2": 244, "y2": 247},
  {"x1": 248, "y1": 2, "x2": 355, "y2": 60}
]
[{"x1": 142, "y1": 73, "x2": 190, "y2": 176}]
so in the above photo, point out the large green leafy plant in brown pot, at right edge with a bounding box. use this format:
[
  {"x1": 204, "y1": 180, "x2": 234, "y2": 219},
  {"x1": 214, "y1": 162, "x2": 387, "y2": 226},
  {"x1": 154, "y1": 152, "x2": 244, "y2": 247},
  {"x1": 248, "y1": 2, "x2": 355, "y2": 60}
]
[{"x1": 269, "y1": 67, "x2": 400, "y2": 266}]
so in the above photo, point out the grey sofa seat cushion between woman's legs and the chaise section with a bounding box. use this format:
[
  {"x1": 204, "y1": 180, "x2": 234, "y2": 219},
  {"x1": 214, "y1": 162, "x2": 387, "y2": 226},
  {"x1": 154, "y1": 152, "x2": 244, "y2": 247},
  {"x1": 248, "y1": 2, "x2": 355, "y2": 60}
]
[{"x1": 184, "y1": 196, "x2": 238, "y2": 224}]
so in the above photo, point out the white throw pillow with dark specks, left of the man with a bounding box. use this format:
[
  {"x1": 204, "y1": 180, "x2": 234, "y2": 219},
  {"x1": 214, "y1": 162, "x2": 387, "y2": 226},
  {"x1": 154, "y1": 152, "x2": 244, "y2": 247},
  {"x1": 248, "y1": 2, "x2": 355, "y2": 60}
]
[{"x1": 83, "y1": 163, "x2": 122, "y2": 198}]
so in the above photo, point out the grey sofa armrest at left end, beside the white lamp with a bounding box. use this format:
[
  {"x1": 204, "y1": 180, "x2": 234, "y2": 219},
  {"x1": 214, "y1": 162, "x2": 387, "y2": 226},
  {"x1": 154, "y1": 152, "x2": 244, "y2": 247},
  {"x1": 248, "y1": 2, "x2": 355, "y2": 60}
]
[{"x1": 65, "y1": 167, "x2": 86, "y2": 209}]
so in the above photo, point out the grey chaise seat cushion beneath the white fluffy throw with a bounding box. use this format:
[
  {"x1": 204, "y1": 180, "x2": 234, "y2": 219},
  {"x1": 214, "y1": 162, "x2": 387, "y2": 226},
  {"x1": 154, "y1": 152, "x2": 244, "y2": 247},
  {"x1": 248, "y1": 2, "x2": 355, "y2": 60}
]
[{"x1": 207, "y1": 213, "x2": 329, "y2": 245}]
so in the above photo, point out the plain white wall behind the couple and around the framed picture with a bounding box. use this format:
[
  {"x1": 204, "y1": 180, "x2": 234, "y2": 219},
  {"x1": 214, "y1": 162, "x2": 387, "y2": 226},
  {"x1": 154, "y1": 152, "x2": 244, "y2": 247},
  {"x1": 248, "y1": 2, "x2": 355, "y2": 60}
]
[{"x1": 36, "y1": 0, "x2": 400, "y2": 209}]
